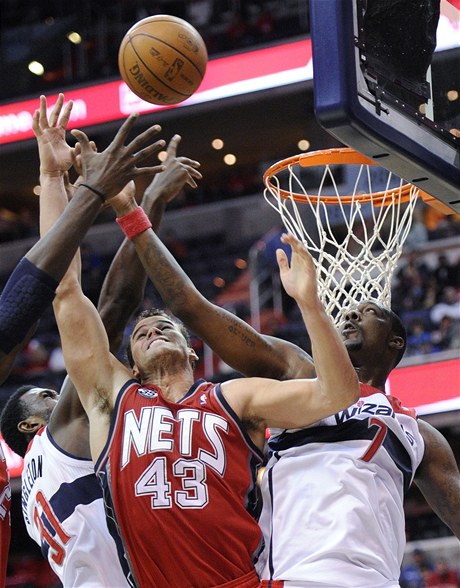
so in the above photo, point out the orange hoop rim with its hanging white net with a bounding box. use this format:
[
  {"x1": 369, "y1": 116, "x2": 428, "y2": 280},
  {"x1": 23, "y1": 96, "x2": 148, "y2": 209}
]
[{"x1": 264, "y1": 148, "x2": 420, "y2": 325}]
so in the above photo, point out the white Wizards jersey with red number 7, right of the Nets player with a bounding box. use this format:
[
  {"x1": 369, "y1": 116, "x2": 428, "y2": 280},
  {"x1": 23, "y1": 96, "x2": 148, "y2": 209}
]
[{"x1": 257, "y1": 384, "x2": 424, "y2": 588}]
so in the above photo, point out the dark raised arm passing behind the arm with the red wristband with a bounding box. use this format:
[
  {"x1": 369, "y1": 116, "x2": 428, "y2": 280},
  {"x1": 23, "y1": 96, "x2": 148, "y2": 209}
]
[{"x1": 98, "y1": 135, "x2": 201, "y2": 353}]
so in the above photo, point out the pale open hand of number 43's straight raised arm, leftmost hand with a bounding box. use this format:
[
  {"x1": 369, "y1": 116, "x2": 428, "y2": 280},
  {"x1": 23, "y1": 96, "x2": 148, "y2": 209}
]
[{"x1": 32, "y1": 94, "x2": 73, "y2": 175}]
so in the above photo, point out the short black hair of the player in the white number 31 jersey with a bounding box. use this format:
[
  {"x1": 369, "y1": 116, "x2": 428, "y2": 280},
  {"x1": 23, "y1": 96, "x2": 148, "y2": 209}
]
[{"x1": 0, "y1": 385, "x2": 36, "y2": 457}]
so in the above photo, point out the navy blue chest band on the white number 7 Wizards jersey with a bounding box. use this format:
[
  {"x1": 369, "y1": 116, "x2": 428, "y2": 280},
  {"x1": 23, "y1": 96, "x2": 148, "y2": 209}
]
[{"x1": 268, "y1": 419, "x2": 413, "y2": 492}]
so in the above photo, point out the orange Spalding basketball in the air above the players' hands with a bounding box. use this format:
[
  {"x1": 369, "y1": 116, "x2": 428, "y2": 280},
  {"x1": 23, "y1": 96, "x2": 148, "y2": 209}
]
[{"x1": 118, "y1": 14, "x2": 208, "y2": 105}]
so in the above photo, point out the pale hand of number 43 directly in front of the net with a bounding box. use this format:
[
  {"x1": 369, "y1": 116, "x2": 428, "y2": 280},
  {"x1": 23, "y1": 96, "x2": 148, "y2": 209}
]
[{"x1": 276, "y1": 234, "x2": 318, "y2": 304}]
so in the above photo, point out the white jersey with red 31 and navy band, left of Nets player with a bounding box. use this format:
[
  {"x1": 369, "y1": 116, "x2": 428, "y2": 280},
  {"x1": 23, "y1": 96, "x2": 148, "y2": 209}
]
[{"x1": 21, "y1": 427, "x2": 128, "y2": 588}]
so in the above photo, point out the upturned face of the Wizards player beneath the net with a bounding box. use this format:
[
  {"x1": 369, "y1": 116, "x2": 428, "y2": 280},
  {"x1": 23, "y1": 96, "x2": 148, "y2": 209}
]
[{"x1": 339, "y1": 301, "x2": 391, "y2": 355}]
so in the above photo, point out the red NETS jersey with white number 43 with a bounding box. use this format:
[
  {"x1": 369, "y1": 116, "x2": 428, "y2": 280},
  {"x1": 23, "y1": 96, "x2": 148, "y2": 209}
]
[{"x1": 96, "y1": 380, "x2": 263, "y2": 588}]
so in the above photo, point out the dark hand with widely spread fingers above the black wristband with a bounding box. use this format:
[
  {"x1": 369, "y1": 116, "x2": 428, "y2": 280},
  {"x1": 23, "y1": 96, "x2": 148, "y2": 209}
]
[{"x1": 72, "y1": 114, "x2": 165, "y2": 198}]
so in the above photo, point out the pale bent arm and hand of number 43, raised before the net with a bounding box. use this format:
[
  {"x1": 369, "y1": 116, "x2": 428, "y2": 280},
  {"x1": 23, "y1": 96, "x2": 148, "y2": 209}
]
[{"x1": 222, "y1": 235, "x2": 359, "y2": 444}]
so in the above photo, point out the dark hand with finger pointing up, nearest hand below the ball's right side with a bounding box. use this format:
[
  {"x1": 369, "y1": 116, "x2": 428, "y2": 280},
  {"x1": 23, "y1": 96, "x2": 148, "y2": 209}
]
[{"x1": 142, "y1": 135, "x2": 203, "y2": 206}]
